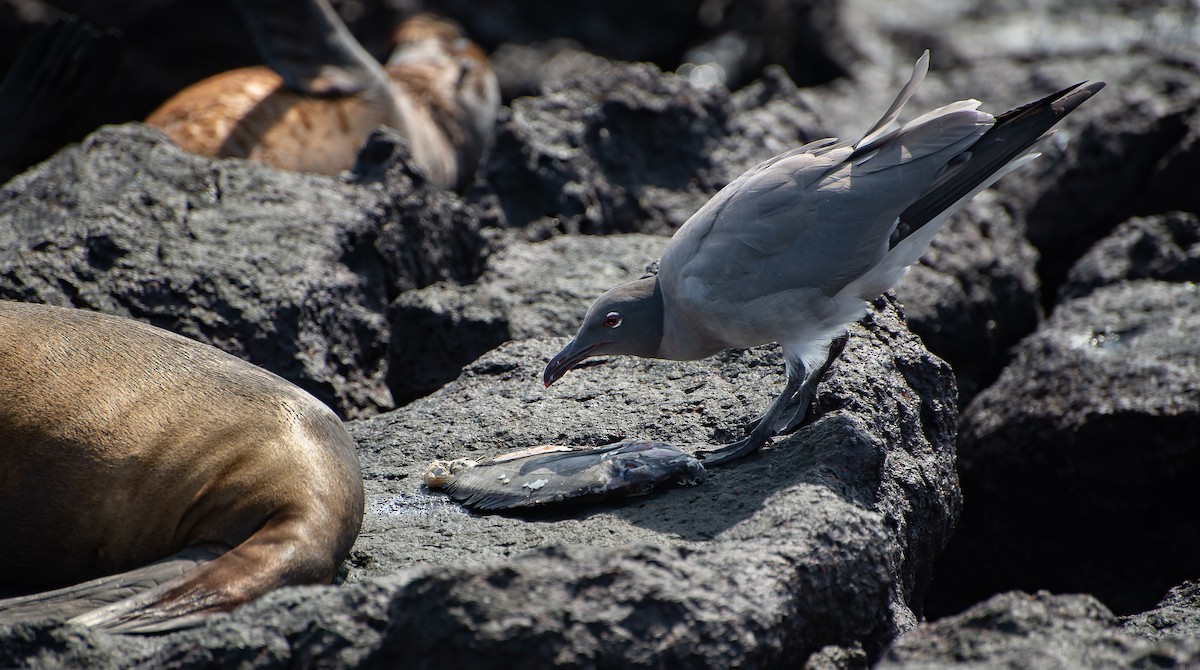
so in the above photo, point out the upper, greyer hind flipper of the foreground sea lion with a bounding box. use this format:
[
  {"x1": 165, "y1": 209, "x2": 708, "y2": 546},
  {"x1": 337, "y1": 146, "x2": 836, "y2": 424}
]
[{"x1": 0, "y1": 546, "x2": 223, "y2": 623}]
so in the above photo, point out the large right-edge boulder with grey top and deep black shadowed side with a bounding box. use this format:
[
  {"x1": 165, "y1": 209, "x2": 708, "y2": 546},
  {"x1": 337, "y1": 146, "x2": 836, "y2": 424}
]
[{"x1": 930, "y1": 280, "x2": 1200, "y2": 614}]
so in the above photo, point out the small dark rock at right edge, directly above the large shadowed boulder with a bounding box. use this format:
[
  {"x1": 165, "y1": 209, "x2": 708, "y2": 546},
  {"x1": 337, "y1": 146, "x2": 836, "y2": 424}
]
[{"x1": 1061, "y1": 211, "x2": 1200, "y2": 299}]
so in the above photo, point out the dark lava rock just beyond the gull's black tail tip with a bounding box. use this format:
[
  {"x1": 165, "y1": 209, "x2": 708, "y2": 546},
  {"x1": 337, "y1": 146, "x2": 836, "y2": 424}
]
[{"x1": 1001, "y1": 55, "x2": 1200, "y2": 295}]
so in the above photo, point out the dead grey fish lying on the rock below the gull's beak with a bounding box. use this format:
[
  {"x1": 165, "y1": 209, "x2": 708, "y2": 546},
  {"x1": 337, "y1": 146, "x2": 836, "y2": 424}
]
[{"x1": 425, "y1": 439, "x2": 707, "y2": 512}]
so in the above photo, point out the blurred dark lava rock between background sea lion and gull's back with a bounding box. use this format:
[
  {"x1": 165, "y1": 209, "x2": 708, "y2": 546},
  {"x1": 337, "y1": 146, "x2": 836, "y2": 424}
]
[{"x1": 481, "y1": 60, "x2": 816, "y2": 234}]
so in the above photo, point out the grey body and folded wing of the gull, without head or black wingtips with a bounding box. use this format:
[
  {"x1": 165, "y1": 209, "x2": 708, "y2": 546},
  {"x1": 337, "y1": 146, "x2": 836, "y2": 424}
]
[{"x1": 659, "y1": 90, "x2": 992, "y2": 346}]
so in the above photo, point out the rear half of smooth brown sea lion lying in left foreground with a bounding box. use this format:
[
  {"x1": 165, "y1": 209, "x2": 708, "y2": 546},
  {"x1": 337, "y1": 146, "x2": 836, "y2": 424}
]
[{"x1": 0, "y1": 301, "x2": 364, "y2": 633}]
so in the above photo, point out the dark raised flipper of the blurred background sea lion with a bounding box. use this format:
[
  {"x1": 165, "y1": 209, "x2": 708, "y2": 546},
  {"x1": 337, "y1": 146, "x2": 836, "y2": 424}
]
[{"x1": 234, "y1": 0, "x2": 388, "y2": 96}]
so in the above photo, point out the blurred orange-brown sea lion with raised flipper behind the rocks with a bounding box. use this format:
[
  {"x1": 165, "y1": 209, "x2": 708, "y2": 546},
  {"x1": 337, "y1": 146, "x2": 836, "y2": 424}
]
[{"x1": 146, "y1": 0, "x2": 500, "y2": 189}]
